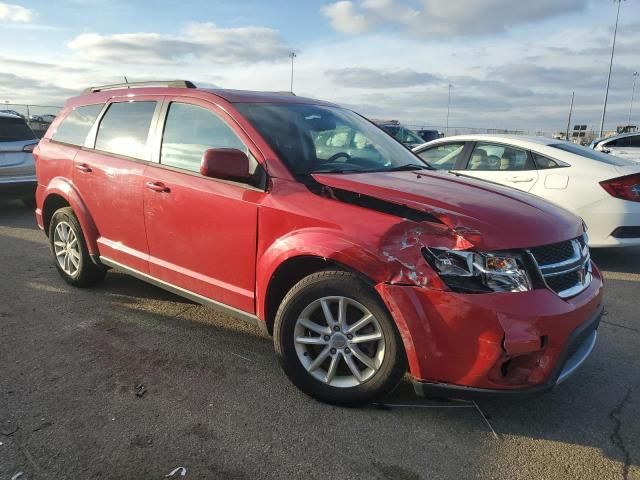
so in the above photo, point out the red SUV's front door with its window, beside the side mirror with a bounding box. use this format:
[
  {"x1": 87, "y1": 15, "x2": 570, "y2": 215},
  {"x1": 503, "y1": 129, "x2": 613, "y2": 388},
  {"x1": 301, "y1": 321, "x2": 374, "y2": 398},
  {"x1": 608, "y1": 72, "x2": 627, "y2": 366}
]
[{"x1": 143, "y1": 98, "x2": 265, "y2": 313}]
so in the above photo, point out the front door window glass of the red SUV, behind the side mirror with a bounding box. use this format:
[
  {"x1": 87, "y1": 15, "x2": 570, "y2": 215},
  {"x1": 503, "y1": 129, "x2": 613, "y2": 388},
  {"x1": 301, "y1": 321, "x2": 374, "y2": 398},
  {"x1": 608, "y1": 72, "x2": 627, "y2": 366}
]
[{"x1": 160, "y1": 103, "x2": 248, "y2": 172}]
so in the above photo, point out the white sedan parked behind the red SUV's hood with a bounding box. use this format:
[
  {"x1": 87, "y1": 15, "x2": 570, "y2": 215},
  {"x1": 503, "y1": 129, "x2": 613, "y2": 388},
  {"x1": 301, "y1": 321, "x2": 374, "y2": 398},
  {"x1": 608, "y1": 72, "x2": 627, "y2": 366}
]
[{"x1": 413, "y1": 135, "x2": 640, "y2": 247}]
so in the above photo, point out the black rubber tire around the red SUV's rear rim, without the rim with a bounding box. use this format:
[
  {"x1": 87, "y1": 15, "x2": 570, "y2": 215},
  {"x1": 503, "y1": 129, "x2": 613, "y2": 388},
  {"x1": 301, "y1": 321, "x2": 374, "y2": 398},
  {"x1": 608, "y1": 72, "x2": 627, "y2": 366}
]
[{"x1": 49, "y1": 207, "x2": 106, "y2": 288}]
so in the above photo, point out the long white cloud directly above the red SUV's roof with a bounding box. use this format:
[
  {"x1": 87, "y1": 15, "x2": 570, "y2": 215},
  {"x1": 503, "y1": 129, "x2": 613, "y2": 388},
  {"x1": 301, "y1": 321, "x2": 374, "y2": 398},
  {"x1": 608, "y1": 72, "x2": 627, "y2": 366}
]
[{"x1": 68, "y1": 23, "x2": 290, "y2": 64}]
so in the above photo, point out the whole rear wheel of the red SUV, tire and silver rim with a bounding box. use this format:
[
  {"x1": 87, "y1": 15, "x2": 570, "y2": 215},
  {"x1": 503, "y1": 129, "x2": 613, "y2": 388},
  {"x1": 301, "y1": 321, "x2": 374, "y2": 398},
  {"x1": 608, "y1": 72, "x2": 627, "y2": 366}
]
[{"x1": 49, "y1": 207, "x2": 106, "y2": 287}]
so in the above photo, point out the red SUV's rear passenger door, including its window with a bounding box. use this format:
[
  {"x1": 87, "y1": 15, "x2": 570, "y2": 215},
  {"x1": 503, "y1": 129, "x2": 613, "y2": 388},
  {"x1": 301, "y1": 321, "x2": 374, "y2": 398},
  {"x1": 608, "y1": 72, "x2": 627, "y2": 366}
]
[{"x1": 73, "y1": 96, "x2": 162, "y2": 273}]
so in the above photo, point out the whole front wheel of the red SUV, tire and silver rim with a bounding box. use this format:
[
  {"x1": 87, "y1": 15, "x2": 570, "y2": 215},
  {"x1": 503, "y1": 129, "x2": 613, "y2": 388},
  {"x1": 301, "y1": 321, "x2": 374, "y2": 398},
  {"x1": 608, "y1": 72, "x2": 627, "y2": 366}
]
[{"x1": 274, "y1": 271, "x2": 407, "y2": 405}]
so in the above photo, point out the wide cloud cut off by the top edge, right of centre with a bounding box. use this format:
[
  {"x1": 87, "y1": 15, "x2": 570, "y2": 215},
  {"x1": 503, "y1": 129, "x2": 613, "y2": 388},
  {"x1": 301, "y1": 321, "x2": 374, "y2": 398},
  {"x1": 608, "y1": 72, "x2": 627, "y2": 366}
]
[{"x1": 321, "y1": 0, "x2": 587, "y2": 37}]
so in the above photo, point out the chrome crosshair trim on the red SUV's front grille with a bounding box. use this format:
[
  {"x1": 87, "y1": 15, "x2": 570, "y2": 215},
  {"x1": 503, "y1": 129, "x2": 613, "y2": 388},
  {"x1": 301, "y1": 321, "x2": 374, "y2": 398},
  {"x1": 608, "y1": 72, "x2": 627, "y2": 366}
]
[{"x1": 527, "y1": 234, "x2": 593, "y2": 298}]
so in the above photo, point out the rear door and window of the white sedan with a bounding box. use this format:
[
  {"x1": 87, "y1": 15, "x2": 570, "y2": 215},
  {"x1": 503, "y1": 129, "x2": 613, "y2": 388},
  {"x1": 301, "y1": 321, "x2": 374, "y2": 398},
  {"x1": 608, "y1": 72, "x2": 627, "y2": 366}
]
[{"x1": 450, "y1": 142, "x2": 539, "y2": 192}]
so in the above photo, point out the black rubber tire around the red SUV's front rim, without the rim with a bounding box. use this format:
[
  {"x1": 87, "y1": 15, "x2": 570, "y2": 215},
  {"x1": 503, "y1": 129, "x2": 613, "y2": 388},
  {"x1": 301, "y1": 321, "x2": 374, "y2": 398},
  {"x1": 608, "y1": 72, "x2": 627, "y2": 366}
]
[{"x1": 274, "y1": 270, "x2": 407, "y2": 406}]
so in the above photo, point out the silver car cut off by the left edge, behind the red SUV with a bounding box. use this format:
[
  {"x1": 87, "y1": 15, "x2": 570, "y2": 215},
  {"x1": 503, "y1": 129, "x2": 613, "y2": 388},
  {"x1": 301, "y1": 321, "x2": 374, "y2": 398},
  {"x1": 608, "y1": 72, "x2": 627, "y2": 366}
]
[{"x1": 0, "y1": 113, "x2": 38, "y2": 206}]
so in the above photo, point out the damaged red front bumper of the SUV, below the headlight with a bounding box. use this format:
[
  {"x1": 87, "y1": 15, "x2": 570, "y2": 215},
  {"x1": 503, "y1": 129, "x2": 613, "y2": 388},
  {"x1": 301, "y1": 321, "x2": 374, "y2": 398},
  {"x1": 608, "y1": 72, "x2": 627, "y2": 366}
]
[{"x1": 377, "y1": 267, "x2": 603, "y2": 397}]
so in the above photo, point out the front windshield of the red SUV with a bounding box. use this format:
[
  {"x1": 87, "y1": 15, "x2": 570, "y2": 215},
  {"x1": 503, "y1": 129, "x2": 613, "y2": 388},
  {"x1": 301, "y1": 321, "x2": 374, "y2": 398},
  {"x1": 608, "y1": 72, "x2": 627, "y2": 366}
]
[{"x1": 236, "y1": 103, "x2": 429, "y2": 175}]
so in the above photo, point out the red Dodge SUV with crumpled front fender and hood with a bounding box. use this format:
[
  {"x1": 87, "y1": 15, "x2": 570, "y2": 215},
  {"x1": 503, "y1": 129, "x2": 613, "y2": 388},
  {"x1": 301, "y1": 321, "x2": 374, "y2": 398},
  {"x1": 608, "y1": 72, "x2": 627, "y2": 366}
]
[{"x1": 34, "y1": 81, "x2": 602, "y2": 405}]
